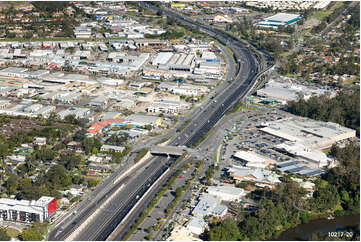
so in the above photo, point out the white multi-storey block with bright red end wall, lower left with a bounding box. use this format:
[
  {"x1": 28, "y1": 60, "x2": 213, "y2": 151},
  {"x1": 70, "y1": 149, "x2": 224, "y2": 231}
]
[{"x1": 0, "y1": 196, "x2": 56, "y2": 223}]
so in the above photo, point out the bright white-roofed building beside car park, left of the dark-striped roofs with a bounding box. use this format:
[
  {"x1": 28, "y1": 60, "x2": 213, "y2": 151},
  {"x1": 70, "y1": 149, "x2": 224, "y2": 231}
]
[{"x1": 233, "y1": 150, "x2": 275, "y2": 168}]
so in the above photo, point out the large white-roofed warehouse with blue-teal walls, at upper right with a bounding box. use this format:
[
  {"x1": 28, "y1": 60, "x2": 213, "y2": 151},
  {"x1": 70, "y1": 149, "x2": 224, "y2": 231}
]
[{"x1": 257, "y1": 13, "x2": 302, "y2": 28}]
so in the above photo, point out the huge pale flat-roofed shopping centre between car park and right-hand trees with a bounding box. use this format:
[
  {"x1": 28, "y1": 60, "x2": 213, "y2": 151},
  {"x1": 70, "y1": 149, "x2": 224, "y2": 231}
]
[{"x1": 261, "y1": 117, "x2": 356, "y2": 149}]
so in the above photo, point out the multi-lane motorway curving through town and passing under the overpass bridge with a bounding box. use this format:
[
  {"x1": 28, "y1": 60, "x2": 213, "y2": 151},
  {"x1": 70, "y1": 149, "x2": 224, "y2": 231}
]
[{"x1": 49, "y1": 3, "x2": 270, "y2": 241}]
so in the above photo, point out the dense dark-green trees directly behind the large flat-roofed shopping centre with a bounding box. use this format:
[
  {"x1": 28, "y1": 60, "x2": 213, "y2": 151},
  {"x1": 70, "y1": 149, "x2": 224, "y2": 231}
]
[{"x1": 286, "y1": 89, "x2": 360, "y2": 135}]
